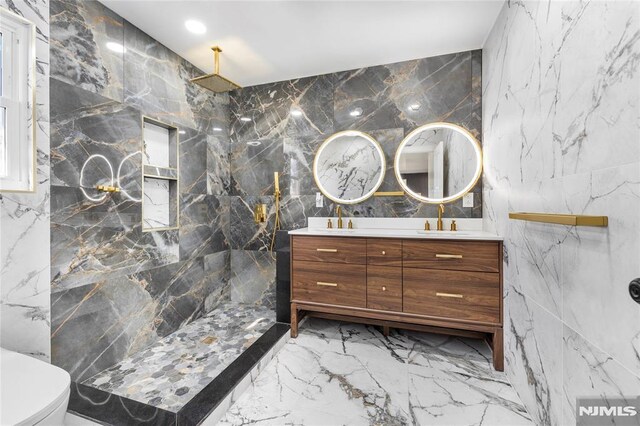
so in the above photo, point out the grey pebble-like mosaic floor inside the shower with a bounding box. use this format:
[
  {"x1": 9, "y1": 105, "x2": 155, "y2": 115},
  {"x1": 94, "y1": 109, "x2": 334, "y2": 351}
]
[{"x1": 84, "y1": 302, "x2": 275, "y2": 412}]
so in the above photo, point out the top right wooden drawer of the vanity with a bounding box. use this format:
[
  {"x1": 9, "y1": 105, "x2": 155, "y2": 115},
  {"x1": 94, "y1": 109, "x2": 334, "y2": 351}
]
[{"x1": 402, "y1": 240, "x2": 500, "y2": 272}]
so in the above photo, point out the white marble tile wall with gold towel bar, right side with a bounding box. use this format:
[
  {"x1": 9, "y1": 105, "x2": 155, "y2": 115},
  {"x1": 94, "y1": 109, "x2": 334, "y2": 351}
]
[{"x1": 482, "y1": 0, "x2": 640, "y2": 425}]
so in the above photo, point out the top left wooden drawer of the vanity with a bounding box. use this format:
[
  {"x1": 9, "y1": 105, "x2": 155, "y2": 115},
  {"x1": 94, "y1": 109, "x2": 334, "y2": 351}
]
[{"x1": 291, "y1": 236, "x2": 367, "y2": 265}]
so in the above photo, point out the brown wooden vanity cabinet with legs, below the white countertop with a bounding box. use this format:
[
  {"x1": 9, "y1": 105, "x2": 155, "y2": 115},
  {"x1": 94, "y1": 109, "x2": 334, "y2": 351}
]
[{"x1": 291, "y1": 235, "x2": 504, "y2": 371}]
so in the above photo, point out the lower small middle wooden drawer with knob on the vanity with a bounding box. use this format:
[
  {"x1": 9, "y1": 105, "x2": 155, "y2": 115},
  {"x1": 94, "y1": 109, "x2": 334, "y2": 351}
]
[{"x1": 367, "y1": 265, "x2": 402, "y2": 312}]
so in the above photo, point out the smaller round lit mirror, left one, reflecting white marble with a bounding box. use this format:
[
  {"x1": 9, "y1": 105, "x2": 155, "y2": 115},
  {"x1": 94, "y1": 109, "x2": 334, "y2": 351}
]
[{"x1": 313, "y1": 130, "x2": 386, "y2": 204}]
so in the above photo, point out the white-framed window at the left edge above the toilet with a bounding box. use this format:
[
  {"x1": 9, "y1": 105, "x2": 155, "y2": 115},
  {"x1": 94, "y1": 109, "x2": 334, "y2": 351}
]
[{"x1": 0, "y1": 8, "x2": 35, "y2": 192}]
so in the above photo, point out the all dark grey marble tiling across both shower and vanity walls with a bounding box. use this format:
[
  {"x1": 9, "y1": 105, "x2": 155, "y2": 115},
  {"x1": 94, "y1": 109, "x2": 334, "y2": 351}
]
[{"x1": 51, "y1": 0, "x2": 482, "y2": 379}]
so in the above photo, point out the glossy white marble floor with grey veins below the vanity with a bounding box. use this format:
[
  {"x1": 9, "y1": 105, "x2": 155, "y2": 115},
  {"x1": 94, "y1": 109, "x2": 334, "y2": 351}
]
[{"x1": 220, "y1": 319, "x2": 533, "y2": 426}]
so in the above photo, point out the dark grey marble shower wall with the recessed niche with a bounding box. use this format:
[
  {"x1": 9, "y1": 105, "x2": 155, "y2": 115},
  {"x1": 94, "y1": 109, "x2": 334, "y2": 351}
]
[{"x1": 46, "y1": 0, "x2": 231, "y2": 380}]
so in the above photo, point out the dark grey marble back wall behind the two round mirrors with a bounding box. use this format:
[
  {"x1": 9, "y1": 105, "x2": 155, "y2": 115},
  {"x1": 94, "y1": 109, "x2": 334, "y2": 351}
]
[{"x1": 228, "y1": 50, "x2": 482, "y2": 303}]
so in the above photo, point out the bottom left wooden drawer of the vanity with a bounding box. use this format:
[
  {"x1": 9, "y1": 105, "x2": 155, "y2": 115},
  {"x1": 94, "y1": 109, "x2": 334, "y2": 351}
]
[{"x1": 292, "y1": 260, "x2": 367, "y2": 308}]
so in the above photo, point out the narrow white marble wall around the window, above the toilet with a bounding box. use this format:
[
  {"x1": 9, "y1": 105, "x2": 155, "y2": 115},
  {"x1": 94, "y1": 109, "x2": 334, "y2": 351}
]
[{"x1": 0, "y1": 0, "x2": 51, "y2": 361}]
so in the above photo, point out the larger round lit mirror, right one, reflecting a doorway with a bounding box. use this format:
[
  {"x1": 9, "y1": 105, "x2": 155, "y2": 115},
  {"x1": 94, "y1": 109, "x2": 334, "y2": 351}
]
[{"x1": 394, "y1": 123, "x2": 482, "y2": 204}]
